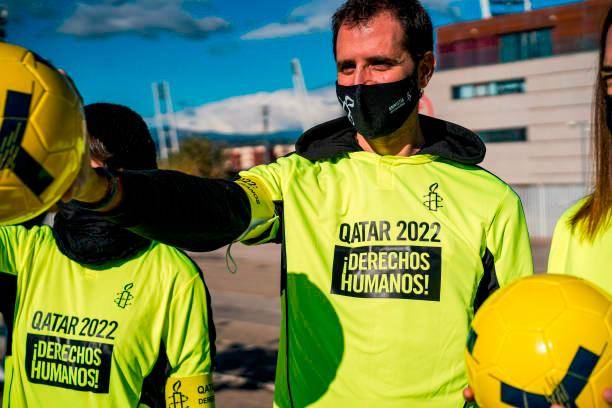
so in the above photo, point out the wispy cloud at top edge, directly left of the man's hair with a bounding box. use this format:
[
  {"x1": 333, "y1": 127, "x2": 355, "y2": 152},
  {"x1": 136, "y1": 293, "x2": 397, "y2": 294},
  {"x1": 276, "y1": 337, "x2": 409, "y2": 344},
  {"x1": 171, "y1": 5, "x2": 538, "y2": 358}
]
[{"x1": 241, "y1": 0, "x2": 344, "y2": 40}]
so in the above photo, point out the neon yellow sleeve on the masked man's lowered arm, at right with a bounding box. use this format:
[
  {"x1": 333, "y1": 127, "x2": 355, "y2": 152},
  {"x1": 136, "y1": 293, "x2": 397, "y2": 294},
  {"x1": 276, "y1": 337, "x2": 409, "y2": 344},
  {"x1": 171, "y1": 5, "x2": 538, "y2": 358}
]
[{"x1": 483, "y1": 187, "x2": 533, "y2": 287}]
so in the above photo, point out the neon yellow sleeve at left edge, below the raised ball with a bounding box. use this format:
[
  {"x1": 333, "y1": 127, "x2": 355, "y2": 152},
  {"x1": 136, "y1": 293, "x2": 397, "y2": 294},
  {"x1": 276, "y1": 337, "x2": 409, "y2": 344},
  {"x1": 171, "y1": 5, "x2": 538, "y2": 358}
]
[{"x1": 0, "y1": 227, "x2": 33, "y2": 275}]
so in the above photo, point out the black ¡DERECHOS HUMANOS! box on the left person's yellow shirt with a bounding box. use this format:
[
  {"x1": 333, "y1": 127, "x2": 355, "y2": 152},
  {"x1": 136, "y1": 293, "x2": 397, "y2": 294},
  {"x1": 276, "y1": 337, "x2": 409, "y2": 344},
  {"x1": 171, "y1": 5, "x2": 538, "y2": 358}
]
[{"x1": 26, "y1": 334, "x2": 113, "y2": 394}]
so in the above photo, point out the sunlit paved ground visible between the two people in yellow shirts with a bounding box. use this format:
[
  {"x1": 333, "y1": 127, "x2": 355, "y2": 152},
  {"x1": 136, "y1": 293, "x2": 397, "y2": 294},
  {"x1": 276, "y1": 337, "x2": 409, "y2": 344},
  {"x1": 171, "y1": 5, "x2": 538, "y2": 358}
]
[{"x1": 0, "y1": 241, "x2": 548, "y2": 408}]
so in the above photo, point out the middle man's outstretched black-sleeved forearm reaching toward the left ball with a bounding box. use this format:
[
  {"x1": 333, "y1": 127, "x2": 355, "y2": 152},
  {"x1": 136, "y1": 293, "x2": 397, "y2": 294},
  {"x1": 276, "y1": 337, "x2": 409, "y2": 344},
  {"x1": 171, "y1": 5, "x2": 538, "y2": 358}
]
[{"x1": 70, "y1": 166, "x2": 251, "y2": 251}]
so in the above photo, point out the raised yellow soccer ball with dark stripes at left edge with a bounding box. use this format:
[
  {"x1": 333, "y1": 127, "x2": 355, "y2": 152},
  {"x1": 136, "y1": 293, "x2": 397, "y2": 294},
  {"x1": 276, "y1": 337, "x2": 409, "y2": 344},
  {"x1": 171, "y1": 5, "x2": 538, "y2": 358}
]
[{"x1": 0, "y1": 42, "x2": 85, "y2": 225}]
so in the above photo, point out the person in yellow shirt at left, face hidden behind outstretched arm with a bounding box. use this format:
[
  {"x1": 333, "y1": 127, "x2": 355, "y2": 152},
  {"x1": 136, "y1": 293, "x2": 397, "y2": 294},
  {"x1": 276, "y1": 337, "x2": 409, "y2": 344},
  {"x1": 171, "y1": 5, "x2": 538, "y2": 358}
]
[{"x1": 0, "y1": 103, "x2": 215, "y2": 407}]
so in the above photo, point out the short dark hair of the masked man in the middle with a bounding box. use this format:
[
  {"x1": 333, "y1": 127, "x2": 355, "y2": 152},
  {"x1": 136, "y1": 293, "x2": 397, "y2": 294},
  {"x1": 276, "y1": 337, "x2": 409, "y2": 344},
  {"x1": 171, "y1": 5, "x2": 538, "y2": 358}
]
[{"x1": 332, "y1": 0, "x2": 433, "y2": 62}]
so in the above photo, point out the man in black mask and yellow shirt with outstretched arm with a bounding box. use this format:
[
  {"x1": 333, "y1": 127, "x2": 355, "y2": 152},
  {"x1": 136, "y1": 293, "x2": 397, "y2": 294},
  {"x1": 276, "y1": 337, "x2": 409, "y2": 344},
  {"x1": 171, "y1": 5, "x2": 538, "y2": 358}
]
[{"x1": 64, "y1": 0, "x2": 533, "y2": 408}]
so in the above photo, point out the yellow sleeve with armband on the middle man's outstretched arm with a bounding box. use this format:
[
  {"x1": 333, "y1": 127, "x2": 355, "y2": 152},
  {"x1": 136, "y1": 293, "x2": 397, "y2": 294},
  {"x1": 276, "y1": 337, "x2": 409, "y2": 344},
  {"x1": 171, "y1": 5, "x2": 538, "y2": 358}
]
[{"x1": 236, "y1": 158, "x2": 288, "y2": 245}]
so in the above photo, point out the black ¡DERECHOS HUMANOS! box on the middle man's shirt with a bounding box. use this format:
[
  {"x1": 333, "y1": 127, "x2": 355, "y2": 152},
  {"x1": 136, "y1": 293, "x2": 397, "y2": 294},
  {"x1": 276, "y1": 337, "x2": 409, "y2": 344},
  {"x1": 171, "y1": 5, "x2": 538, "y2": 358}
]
[{"x1": 331, "y1": 245, "x2": 442, "y2": 301}]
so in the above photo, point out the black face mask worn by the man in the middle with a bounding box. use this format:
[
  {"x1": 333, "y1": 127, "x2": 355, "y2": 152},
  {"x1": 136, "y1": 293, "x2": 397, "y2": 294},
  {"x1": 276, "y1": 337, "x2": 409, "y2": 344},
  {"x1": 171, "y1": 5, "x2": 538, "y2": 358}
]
[{"x1": 336, "y1": 70, "x2": 422, "y2": 139}]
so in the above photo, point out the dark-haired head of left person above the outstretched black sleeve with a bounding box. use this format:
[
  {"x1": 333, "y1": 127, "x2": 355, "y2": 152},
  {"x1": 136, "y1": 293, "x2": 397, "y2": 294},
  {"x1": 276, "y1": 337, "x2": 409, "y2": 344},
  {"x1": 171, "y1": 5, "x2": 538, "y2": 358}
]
[{"x1": 84, "y1": 103, "x2": 157, "y2": 170}]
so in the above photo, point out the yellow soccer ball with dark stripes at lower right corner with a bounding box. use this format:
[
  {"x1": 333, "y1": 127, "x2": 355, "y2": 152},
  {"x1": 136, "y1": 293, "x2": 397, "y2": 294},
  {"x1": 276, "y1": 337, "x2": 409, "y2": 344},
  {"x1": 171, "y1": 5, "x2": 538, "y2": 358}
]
[{"x1": 465, "y1": 274, "x2": 612, "y2": 408}]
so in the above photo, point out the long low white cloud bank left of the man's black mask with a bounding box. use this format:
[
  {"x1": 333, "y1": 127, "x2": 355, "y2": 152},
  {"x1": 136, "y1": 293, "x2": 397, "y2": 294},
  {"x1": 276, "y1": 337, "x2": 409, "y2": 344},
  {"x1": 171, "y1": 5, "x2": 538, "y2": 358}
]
[{"x1": 177, "y1": 86, "x2": 343, "y2": 134}]
